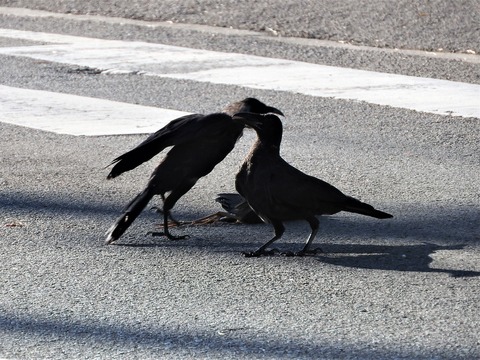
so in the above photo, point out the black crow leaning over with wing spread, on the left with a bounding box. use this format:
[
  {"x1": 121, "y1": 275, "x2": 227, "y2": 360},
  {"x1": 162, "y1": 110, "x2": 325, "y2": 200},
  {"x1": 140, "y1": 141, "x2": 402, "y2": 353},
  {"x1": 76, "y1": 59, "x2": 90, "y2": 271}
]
[{"x1": 106, "y1": 98, "x2": 283, "y2": 244}]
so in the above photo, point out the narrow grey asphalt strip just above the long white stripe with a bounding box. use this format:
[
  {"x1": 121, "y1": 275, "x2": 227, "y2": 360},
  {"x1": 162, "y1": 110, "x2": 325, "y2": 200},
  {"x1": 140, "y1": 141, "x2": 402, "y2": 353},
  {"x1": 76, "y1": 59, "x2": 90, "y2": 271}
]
[{"x1": 0, "y1": 8, "x2": 480, "y2": 84}]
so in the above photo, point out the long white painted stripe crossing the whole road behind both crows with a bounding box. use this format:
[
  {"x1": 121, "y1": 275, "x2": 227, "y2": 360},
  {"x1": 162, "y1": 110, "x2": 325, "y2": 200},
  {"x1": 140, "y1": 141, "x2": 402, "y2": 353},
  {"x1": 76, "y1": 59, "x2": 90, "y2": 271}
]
[{"x1": 0, "y1": 29, "x2": 480, "y2": 118}]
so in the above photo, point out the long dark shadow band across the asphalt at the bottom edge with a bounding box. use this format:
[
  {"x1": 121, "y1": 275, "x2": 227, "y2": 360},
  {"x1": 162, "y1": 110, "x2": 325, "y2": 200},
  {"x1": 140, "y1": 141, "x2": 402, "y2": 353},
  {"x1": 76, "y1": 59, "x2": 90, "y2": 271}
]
[{"x1": 0, "y1": 311, "x2": 468, "y2": 359}]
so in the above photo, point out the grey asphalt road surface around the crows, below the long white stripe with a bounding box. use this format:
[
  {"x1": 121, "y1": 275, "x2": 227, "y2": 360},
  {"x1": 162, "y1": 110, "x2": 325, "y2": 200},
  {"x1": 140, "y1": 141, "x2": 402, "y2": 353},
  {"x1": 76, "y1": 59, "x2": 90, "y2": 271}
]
[{"x1": 0, "y1": 1, "x2": 480, "y2": 359}]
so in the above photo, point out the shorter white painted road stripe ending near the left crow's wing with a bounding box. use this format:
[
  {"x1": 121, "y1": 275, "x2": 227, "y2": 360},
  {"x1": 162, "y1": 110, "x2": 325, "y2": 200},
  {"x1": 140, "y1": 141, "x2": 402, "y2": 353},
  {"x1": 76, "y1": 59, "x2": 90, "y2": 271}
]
[{"x1": 0, "y1": 85, "x2": 188, "y2": 136}]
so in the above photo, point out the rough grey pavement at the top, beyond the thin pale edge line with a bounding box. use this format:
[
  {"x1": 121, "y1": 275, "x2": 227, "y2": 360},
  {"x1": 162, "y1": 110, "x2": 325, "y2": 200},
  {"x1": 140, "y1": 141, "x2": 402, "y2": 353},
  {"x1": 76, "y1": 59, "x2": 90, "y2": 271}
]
[{"x1": 0, "y1": 0, "x2": 480, "y2": 53}]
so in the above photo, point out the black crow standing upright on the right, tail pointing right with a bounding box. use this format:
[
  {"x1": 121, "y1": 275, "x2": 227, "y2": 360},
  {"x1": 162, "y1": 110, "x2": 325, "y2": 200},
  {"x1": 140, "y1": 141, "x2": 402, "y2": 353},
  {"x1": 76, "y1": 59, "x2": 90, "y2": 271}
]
[{"x1": 233, "y1": 113, "x2": 393, "y2": 257}]
